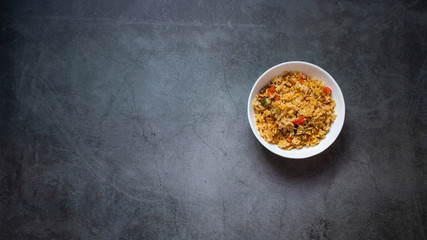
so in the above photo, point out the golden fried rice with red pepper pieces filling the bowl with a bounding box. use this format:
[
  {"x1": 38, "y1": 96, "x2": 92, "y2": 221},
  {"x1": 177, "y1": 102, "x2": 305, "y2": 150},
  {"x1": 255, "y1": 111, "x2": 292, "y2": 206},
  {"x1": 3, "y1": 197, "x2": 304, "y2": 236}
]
[{"x1": 252, "y1": 71, "x2": 337, "y2": 150}]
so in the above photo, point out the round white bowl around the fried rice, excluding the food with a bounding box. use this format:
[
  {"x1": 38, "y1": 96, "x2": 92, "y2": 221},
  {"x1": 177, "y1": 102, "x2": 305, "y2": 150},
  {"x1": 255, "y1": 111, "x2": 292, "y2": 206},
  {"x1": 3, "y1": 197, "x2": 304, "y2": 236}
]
[{"x1": 248, "y1": 61, "x2": 345, "y2": 159}]
